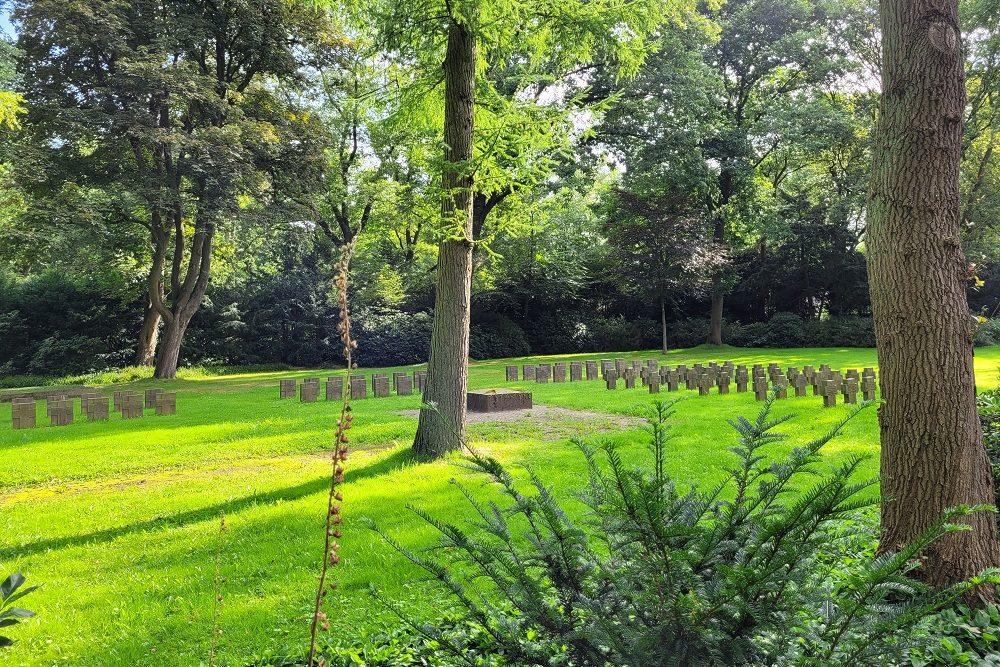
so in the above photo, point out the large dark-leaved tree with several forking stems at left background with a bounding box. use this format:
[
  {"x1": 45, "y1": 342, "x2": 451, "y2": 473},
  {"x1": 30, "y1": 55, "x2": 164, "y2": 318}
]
[{"x1": 14, "y1": 0, "x2": 334, "y2": 378}]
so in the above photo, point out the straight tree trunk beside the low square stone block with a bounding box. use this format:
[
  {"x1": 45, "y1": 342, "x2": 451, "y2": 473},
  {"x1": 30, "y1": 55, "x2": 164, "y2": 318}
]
[{"x1": 413, "y1": 19, "x2": 476, "y2": 457}]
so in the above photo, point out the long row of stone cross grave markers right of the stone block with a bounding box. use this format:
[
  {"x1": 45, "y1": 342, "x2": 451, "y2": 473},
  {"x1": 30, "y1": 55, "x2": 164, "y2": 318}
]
[{"x1": 506, "y1": 359, "x2": 876, "y2": 407}]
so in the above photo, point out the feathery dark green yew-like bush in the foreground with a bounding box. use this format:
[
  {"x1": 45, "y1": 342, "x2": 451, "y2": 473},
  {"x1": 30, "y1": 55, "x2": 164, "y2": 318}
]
[{"x1": 364, "y1": 401, "x2": 983, "y2": 667}]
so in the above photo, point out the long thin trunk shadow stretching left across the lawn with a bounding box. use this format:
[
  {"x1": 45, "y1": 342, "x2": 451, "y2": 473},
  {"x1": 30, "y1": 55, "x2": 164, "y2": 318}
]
[{"x1": 0, "y1": 447, "x2": 418, "y2": 561}]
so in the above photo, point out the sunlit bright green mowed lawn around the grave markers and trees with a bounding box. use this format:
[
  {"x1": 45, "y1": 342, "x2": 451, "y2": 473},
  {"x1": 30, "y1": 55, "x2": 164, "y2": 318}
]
[{"x1": 0, "y1": 348, "x2": 1000, "y2": 666}]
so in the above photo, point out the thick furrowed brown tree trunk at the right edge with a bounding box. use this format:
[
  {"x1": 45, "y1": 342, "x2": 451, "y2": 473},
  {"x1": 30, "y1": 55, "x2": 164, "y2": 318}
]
[{"x1": 867, "y1": 0, "x2": 1000, "y2": 585}]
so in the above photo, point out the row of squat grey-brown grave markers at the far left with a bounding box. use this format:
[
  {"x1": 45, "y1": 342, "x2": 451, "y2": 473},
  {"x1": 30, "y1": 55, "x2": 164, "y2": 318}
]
[{"x1": 11, "y1": 389, "x2": 177, "y2": 429}]
